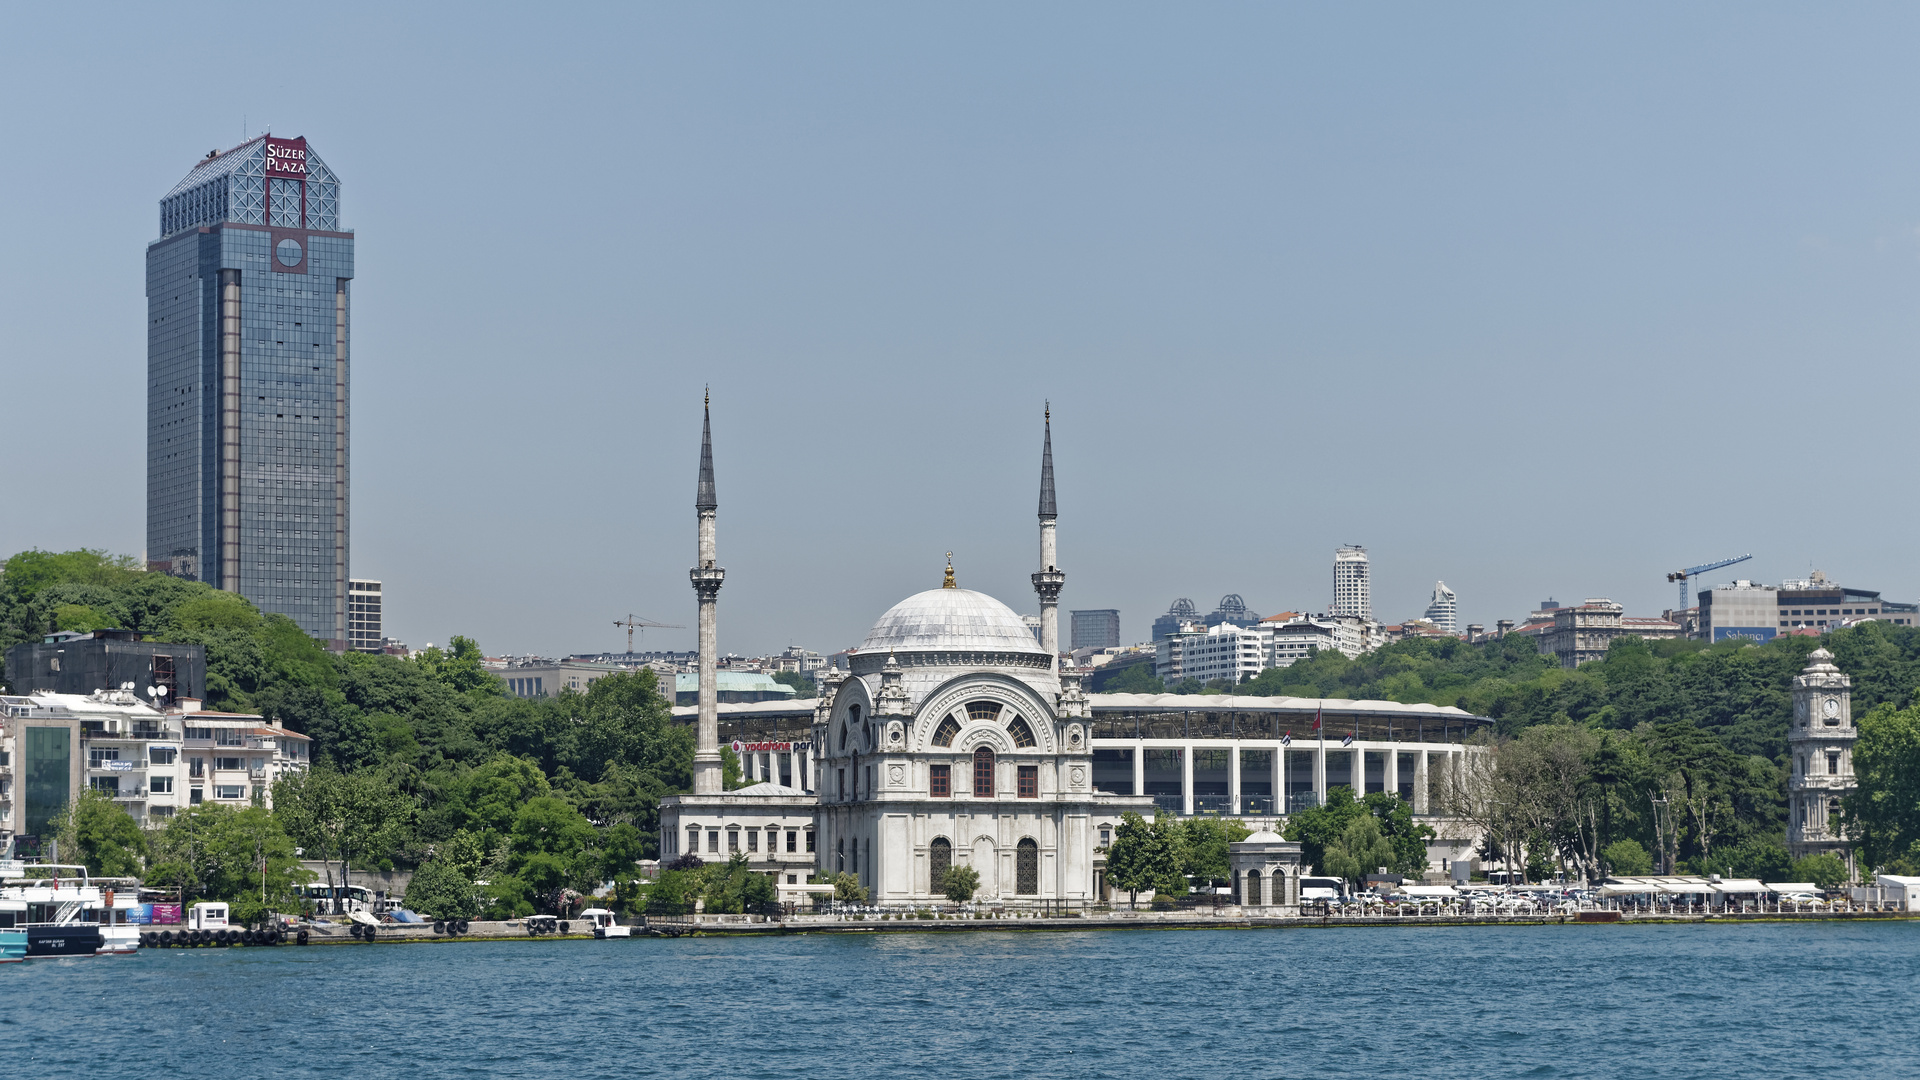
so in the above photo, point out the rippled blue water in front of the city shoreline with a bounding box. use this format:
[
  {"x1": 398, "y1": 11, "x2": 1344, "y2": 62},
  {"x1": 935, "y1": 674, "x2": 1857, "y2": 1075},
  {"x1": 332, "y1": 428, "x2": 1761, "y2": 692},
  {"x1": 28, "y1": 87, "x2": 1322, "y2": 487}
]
[{"x1": 0, "y1": 922, "x2": 1920, "y2": 1080}]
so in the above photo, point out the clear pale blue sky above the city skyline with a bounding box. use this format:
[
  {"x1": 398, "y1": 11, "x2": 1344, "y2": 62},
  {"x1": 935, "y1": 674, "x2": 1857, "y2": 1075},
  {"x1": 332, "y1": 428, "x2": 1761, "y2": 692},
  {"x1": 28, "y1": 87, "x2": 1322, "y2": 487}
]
[{"x1": 0, "y1": 2, "x2": 1920, "y2": 655}]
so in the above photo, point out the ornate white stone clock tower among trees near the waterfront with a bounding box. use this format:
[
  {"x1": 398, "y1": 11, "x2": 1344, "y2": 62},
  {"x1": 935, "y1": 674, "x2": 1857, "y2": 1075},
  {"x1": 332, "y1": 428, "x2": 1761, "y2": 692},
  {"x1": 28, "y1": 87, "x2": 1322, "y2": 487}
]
[{"x1": 1788, "y1": 650, "x2": 1860, "y2": 874}]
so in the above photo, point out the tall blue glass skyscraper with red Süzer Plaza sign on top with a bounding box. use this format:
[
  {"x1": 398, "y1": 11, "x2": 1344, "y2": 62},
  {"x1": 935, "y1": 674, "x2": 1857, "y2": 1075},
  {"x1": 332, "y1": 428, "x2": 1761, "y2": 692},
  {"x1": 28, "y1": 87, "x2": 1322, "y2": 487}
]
[{"x1": 146, "y1": 135, "x2": 353, "y2": 638}]
